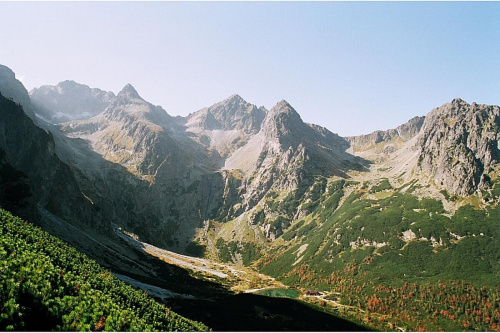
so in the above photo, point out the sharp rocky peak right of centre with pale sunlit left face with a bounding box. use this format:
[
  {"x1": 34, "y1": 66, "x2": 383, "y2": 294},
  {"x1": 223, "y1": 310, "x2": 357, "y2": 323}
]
[{"x1": 225, "y1": 101, "x2": 366, "y2": 207}]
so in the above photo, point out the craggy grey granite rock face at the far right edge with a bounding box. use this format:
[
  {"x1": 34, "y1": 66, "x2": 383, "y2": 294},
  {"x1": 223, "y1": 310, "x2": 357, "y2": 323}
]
[{"x1": 415, "y1": 99, "x2": 500, "y2": 195}]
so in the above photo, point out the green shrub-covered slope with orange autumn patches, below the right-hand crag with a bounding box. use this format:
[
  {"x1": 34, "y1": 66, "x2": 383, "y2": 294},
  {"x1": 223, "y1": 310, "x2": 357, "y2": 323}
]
[{"x1": 260, "y1": 179, "x2": 500, "y2": 331}]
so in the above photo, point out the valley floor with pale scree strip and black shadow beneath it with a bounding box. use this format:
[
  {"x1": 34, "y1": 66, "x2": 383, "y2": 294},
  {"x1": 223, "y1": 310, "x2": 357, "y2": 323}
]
[{"x1": 30, "y1": 208, "x2": 367, "y2": 331}]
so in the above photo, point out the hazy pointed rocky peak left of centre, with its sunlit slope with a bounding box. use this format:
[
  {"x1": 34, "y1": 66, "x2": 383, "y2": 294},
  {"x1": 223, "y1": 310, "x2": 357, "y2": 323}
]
[{"x1": 62, "y1": 84, "x2": 219, "y2": 182}]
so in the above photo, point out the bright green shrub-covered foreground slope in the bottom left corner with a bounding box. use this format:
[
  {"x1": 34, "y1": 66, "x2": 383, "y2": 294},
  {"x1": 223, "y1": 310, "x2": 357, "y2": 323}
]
[{"x1": 0, "y1": 209, "x2": 208, "y2": 331}]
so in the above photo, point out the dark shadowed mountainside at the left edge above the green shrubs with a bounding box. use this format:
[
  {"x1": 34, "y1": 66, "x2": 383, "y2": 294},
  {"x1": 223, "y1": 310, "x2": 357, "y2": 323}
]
[{"x1": 0, "y1": 92, "x2": 100, "y2": 229}]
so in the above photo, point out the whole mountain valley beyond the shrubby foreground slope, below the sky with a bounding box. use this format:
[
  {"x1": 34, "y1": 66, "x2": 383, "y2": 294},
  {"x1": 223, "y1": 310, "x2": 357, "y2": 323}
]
[{"x1": 0, "y1": 66, "x2": 500, "y2": 331}]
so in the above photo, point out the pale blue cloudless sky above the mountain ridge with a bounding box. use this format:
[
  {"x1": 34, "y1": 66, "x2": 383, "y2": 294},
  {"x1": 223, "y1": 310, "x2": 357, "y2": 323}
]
[{"x1": 0, "y1": 2, "x2": 500, "y2": 136}]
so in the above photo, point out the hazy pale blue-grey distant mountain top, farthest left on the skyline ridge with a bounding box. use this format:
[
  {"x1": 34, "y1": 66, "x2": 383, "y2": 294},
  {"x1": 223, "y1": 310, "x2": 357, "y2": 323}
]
[{"x1": 29, "y1": 81, "x2": 116, "y2": 124}]
